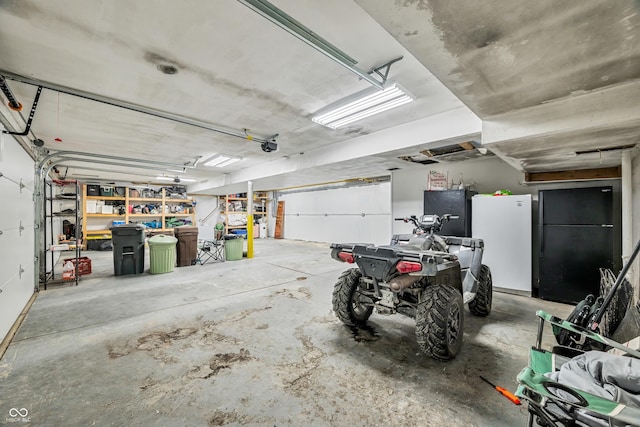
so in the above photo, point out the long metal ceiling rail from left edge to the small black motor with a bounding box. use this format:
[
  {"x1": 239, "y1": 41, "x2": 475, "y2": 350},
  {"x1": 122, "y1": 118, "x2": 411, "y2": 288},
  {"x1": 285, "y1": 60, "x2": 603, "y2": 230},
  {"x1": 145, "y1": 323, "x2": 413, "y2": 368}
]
[{"x1": 0, "y1": 70, "x2": 273, "y2": 143}]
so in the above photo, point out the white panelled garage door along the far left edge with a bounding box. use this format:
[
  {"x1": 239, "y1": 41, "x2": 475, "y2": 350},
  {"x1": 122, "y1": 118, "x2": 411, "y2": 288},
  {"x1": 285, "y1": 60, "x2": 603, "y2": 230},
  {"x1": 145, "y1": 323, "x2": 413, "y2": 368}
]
[{"x1": 0, "y1": 135, "x2": 36, "y2": 340}]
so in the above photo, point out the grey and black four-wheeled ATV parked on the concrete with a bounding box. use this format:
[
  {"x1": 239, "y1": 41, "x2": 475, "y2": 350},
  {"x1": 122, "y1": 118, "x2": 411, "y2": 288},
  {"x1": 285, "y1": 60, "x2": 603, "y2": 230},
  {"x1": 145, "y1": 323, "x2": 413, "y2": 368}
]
[{"x1": 330, "y1": 214, "x2": 493, "y2": 361}]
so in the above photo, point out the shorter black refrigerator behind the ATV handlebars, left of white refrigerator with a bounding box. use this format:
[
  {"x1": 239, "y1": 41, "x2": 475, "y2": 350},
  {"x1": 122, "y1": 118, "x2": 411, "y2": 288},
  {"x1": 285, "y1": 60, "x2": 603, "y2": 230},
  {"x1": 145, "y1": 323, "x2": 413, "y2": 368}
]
[{"x1": 424, "y1": 190, "x2": 476, "y2": 237}]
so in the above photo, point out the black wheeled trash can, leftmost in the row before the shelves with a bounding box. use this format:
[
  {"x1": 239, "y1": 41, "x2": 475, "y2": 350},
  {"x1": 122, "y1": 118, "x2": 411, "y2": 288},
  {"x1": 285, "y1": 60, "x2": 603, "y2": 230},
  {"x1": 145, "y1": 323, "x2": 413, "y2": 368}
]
[{"x1": 111, "y1": 224, "x2": 144, "y2": 276}]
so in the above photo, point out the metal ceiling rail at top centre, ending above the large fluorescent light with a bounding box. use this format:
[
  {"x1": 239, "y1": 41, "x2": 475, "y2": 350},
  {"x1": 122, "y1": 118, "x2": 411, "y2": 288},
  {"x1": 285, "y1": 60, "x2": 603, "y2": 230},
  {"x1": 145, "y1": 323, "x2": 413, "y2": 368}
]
[{"x1": 238, "y1": 0, "x2": 384, "y2": 89}]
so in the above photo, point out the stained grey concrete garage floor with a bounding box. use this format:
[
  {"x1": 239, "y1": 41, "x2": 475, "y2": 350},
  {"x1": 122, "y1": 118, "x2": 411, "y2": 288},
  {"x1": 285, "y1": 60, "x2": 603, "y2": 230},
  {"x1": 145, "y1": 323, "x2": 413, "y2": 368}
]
[{"x1": 0, "y1": 239, "x2": 572, "y2": 427}]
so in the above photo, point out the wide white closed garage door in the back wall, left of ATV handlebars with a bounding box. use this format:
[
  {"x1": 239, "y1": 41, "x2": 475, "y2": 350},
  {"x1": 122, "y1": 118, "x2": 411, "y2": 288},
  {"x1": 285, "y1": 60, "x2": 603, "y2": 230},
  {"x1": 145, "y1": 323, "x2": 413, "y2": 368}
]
[{"x1": 278, "y1": 182, "x2": 392, "y2": 244}]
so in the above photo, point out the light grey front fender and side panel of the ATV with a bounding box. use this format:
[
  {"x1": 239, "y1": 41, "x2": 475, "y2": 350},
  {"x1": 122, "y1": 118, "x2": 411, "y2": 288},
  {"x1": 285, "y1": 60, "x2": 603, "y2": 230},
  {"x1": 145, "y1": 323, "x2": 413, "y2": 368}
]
[{"x1": 444, "y1": 236, "x2": 484, "y2": 304}]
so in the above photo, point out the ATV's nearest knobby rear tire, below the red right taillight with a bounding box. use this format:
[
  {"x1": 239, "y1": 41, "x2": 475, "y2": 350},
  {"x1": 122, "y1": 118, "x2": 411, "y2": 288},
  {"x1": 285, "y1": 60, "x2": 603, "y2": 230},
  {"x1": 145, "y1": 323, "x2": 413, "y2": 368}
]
[{"x1": 416, "y1": 285, "x2": 464, "y2": 360}]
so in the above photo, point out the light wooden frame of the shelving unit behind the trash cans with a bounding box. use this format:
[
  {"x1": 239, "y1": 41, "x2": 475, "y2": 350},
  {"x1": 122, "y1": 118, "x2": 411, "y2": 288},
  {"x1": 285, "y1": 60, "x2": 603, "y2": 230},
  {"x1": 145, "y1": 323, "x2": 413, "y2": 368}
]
[{"x1": 82, "y1": 184, "x2": 196, "y2": 244}]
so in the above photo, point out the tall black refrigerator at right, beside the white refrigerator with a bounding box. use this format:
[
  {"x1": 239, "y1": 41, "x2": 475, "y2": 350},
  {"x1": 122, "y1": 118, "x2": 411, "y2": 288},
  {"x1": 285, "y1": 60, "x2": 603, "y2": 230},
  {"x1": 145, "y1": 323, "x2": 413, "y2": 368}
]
[{"x1": 538, "y1": 186, "x2": 619, "y2": 304}]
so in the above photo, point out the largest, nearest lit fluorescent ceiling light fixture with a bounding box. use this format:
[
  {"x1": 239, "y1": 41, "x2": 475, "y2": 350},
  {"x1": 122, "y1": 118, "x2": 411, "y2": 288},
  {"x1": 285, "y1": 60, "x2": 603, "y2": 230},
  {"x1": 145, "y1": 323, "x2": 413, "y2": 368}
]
[{"x1": 311, "y1": 83, "x2": 414, "y2": 129}]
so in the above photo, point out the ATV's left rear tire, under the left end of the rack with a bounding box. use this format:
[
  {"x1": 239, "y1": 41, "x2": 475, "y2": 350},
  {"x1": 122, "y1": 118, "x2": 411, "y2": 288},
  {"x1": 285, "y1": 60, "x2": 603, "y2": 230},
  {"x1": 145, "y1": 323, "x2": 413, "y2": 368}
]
[{"x1": 333, "y1": 268, "x2": 373, "y2": 326}]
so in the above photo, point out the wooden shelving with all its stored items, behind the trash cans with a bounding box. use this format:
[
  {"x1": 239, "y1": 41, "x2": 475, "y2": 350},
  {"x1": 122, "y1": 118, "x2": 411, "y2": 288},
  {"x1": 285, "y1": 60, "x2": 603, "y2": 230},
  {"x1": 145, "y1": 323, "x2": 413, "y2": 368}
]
[{"x1": 82, "y1": 185, "x2": 195, "y2": 244}]
